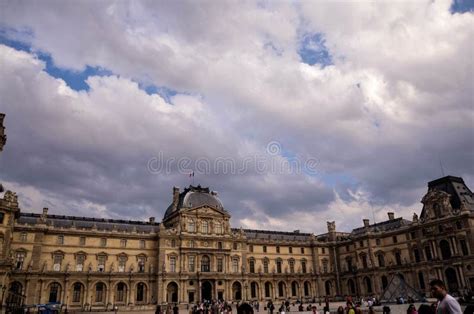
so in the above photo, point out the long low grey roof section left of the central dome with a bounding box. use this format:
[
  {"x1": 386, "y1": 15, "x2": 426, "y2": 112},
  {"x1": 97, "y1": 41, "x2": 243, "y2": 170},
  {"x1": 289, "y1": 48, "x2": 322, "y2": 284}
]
[{"x1": 18, "y1": 213, "x2": 159, "y2": 233}]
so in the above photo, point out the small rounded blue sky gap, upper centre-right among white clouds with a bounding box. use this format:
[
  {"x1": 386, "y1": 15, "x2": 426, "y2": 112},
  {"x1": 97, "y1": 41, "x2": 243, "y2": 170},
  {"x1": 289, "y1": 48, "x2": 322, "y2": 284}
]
[{"x1": 298, "y1": 33, "x2": 333, "y2": 68}]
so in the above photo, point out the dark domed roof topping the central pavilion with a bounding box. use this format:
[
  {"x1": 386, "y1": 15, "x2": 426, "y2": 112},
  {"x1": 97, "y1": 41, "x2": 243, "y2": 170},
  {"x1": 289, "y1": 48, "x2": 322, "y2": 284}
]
[{"x1": 164, "y1": 185, "x2": 224, "y2": 219}]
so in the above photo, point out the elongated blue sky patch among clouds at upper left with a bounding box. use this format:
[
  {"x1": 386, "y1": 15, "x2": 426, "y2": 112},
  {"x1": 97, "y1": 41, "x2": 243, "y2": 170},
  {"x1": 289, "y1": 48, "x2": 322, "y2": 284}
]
[{"x1": 0, "y1": 29, "x2": 113, "y2": 91}]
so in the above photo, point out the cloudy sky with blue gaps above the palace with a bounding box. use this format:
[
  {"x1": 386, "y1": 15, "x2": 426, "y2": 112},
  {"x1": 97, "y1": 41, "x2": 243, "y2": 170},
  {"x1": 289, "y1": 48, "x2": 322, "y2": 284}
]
[{"x1": 0, "y1": 0, "x2": 474, "y2": 234}]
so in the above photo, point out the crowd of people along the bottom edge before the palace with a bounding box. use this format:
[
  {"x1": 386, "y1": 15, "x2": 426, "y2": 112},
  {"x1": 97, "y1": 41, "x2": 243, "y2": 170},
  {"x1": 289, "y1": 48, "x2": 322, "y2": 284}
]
[{"x1": 155, "y1": 280, "x2": 474, "y2": 314}]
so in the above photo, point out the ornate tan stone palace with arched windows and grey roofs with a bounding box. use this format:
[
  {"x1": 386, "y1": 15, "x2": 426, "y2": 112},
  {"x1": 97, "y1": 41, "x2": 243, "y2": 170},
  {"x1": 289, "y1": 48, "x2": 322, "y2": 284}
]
[{"x1": 0, "y1": 176, "x2": 474, "y2": 310}]
